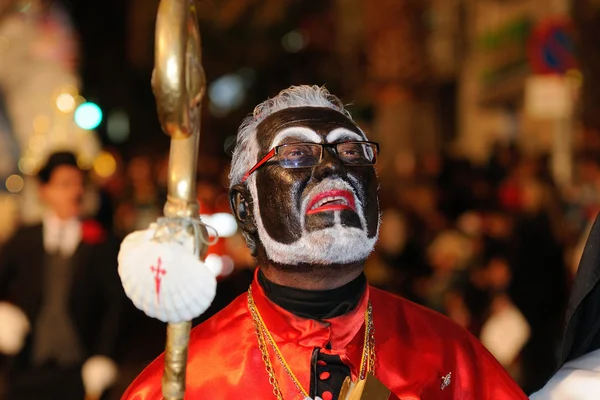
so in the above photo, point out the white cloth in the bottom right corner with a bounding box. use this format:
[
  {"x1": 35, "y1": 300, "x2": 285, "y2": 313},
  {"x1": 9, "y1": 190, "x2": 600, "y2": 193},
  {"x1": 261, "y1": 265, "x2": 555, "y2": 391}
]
[{"x1": 530, "y1": 349, "x2": 600, "y2": 400}]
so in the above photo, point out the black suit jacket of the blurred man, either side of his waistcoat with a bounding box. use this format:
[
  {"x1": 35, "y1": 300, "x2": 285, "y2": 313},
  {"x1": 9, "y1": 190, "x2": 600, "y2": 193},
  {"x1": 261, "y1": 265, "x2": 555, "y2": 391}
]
[{"x1": 0, "y1": 224, "x2": 127, "y2": 371}]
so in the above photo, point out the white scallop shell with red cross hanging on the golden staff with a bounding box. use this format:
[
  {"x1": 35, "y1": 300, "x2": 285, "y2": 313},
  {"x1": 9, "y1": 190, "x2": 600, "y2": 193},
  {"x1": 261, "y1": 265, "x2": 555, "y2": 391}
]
[{"x1": 118, "y1": 226, "x2": 220, "y2": 323}]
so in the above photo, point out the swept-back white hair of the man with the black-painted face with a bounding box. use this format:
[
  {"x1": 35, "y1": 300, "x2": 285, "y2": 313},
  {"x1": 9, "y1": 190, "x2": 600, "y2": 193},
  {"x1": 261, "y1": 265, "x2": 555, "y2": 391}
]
[{"x1": 229, "y1": 85, "x2": 352, "y2": 187}]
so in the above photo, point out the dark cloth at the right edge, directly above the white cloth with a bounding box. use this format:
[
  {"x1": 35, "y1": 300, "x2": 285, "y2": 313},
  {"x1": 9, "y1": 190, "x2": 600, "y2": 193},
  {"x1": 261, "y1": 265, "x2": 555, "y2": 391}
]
[{"x1": 560, "y1": 214, "x2": 600, "y2": 366}]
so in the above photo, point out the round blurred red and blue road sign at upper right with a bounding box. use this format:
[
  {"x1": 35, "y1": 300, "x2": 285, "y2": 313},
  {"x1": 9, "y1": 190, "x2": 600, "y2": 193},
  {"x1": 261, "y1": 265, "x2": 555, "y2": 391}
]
[{"x1": 528, "y1": 17, "x2": 577, "y2": 74}]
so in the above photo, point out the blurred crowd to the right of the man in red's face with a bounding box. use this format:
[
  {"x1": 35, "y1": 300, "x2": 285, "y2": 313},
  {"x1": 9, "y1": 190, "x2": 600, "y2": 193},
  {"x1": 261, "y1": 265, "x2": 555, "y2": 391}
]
[{"x1": 366, "y1": 139, "x2": 600, "y2": 393}]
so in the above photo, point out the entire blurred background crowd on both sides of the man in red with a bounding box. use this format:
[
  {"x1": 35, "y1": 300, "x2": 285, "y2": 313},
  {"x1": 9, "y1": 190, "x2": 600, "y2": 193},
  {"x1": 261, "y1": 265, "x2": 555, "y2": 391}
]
[{"x1": 3, "y1": 137, "x2": 600, "y2": 399}]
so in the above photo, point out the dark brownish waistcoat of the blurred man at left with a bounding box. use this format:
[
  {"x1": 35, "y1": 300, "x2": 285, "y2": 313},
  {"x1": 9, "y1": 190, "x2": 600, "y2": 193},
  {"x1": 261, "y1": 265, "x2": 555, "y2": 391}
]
[{"x1": 33, "y1": 253, "x2": 83, "y2": 367}]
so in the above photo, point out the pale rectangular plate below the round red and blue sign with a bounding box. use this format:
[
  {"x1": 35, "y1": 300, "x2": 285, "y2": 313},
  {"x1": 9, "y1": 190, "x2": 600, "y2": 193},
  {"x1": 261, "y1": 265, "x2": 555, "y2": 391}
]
[{"x1": 525, "y1": 75, "x2": 574, "y2": 119}]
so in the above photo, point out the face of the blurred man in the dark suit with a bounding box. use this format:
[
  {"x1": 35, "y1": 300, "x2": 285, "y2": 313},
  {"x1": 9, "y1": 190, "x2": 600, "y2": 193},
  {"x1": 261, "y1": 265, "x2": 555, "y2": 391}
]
[{"x1": 40, "y1": 165, "x2": 84, "y2": 219}]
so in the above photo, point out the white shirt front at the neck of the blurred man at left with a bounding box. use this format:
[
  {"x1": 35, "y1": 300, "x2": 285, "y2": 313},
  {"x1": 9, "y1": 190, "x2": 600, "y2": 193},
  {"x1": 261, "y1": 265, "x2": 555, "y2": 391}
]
[{"x1": 42, "y1": 213, "x2": 81, "y2": 257}]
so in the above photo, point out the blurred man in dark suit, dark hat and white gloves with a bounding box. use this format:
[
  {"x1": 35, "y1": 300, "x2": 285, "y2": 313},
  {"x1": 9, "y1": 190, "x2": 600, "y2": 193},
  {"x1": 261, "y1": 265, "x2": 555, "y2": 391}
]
[{"x1": 0, "y1": 152, "x2": 123, "y2": 400}]
